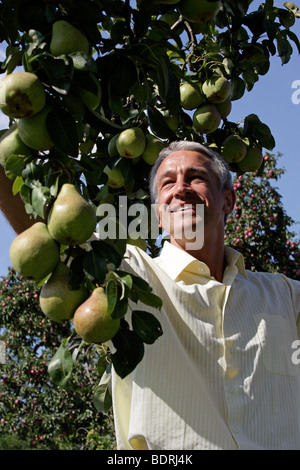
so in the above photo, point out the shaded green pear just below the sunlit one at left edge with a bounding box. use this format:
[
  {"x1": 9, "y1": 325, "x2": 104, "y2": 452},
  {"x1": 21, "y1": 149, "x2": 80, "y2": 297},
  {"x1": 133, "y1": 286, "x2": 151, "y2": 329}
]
[{"x1": 18, "y1": 105, "x2": 53, "y2": 152}]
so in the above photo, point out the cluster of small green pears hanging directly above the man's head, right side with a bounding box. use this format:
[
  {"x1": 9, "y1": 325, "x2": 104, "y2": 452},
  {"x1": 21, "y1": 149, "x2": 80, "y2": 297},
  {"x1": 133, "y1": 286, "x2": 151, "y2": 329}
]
[{"x1": 180, "y1": 75, "x2": 231, "y2": 134}]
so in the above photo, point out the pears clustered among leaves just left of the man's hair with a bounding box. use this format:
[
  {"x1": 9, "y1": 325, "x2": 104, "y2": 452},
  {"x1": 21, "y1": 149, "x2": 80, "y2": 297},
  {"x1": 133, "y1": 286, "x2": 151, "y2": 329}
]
[{"x1": 103, "y1": 127, "x2": 166, "y2": 189}]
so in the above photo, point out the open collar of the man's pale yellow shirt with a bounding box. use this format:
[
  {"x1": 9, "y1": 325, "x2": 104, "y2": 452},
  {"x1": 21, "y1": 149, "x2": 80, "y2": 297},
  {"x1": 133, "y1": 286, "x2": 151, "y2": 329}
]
[{"x1": 155, "y1": 241, "x2": 247, "y2": 280}]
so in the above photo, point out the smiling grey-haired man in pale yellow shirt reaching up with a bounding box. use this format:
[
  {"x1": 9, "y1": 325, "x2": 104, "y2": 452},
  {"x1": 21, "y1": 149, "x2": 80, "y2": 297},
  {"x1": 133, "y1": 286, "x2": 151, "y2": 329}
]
[{"x1": 0, "y1": 142, "x2": 300, "y2": 450}]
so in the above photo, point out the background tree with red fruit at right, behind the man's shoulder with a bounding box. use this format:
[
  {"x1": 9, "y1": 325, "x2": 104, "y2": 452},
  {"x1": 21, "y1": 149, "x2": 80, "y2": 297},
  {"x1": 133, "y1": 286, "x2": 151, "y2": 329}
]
[{"x1": 225, "y1": 153, "x2": 300, "y2": 280}]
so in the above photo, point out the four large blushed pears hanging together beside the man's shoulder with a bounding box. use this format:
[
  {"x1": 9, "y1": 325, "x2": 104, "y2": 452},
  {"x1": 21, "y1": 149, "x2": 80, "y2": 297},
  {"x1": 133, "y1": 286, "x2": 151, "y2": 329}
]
[{"x1": 9, "y1": 183, "x2": 120, "y2": 343}]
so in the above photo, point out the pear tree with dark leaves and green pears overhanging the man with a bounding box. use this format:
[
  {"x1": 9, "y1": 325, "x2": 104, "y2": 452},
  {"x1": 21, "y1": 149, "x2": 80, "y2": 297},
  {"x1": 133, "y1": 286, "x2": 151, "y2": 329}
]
[{"x1": 0, "y1": 0, "x2": 300, "y2": 406}]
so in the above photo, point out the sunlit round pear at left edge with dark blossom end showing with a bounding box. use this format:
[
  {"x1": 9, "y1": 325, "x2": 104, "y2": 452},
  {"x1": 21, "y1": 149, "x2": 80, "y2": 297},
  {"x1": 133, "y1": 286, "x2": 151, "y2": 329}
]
[{"x1": 0, "y1": 72, "x2": 46, "y2": 119}]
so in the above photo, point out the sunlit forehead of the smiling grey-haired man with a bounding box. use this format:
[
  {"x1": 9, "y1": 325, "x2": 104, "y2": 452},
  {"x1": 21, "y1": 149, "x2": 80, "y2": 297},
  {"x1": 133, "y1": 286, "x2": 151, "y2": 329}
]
[{"x1": 157, "y1": 150, "x2": 212, "y2": 179}]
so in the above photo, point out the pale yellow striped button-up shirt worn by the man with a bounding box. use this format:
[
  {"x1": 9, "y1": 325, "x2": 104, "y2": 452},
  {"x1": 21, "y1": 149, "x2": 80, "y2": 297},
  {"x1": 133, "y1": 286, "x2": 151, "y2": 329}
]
[{"x1": 112, "y1": 242, "x2": 300, "y2": 450}]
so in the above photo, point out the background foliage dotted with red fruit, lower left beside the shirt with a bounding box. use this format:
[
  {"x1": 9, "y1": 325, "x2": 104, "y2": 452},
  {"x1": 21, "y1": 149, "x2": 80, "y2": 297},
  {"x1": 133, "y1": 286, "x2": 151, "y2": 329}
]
[{"x1": 0, "y1": 269, "x2": 114, "y2": 449}]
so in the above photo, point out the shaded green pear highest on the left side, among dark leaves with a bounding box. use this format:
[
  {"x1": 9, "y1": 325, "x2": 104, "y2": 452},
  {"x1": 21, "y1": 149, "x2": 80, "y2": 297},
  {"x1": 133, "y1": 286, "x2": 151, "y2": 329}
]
[{"x1": 50, "y1": 20, "x2": 90, "y2": 57}]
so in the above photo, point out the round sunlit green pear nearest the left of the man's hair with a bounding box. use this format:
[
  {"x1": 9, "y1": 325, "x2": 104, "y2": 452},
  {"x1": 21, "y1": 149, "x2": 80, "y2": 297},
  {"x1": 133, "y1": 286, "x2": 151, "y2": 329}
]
[{"x1": 116, "y1": 127, "x2": 146, "y2": 158}]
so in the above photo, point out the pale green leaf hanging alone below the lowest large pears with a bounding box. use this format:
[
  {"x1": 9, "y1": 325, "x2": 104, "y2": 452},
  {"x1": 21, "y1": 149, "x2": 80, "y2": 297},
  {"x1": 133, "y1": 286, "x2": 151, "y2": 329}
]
[{"x1": 48, "y1": 343, "x2": 73, "y2": 390}]
